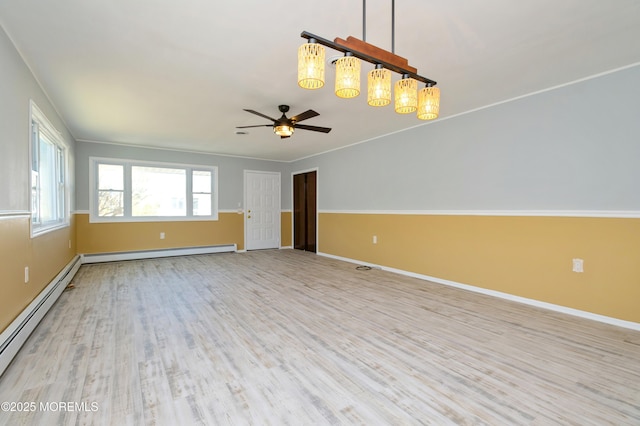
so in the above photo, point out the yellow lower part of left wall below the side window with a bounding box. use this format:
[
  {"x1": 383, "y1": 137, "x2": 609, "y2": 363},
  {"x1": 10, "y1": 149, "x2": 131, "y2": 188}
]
[{"x1": 0, "y1": 215, "x2": 76, "y2": 332}]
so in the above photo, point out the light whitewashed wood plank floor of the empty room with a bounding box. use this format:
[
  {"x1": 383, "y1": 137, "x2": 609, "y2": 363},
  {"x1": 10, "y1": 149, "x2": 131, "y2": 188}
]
[{"x1": 0, "y1": 250, "x2": 640, "y2": 425}]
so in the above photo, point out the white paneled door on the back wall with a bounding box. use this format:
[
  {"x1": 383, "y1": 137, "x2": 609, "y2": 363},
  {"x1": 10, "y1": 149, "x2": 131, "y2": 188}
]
[{"x1": 244, "y1": 170, "x2": 280, "y2": 250}]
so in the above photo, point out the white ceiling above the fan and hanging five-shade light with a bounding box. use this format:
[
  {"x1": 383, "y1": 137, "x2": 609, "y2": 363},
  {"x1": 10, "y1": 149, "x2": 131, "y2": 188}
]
[{"x1": 0, "y1": 0, "x2": 640, "y2": 161}]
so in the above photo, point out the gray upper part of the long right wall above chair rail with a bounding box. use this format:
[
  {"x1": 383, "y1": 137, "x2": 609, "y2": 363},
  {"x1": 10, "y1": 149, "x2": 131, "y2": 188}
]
[{"x1": 289, "y1": 66, "x2": 640, "y2": 212}]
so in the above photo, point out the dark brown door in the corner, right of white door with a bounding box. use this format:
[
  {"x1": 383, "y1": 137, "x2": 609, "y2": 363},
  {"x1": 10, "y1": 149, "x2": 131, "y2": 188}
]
[{"x1": 293, "y1": 171, "x2": 317, "y2": 253}]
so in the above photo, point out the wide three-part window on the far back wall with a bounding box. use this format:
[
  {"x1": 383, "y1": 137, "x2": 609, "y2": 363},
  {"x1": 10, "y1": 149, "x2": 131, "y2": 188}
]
[{"x1": 90, "y1": 158, "x2": 218, "y2": 222}]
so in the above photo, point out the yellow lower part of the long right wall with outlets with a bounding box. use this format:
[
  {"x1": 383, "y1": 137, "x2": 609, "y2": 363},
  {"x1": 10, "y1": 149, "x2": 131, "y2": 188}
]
[{"x1": 319, "y1": 213, "x2": 640, "y2": 323}]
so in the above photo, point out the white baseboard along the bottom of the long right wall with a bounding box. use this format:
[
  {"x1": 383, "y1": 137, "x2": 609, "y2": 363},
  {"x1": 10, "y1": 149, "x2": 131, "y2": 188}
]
[{"x1": 318, "y1": 252, "x2": 640, "y2": 331}]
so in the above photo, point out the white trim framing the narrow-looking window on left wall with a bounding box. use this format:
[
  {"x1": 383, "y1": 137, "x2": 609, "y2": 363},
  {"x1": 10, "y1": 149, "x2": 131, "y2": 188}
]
[{"x1": 28, "y1": 99, "x2": 71, "y2": 238}]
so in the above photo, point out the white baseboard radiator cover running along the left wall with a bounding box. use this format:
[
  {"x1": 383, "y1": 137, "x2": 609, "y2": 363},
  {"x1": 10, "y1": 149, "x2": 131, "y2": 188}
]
[{"x1": 0, "y1": 256, "x2": 82, "y2": 376}]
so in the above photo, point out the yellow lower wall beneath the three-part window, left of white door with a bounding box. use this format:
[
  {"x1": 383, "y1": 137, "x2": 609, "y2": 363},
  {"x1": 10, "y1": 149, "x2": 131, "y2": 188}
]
[{"x1": 76, "y1": 213, "x2": 244, "y2": 254}]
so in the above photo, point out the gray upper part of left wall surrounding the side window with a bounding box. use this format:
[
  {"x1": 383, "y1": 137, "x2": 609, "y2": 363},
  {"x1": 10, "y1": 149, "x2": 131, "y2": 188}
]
[{"x1": 0, "y1": 27, "x2": 75, "y2": 212}]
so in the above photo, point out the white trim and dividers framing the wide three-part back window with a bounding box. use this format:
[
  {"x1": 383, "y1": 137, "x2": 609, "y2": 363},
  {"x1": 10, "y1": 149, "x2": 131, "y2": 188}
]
[{"x1": 89, "y1": 157, "x2": 219, "y2": 223}]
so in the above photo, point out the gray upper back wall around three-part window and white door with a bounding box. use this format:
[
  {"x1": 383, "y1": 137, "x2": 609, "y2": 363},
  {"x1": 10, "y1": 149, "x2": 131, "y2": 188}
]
[{"x1": 76, "y1": 142, "x2": 291, "y2": 210}]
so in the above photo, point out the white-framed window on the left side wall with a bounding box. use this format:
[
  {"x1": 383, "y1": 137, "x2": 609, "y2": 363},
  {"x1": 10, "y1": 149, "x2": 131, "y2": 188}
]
[{"x1": 30, "y1": 101, "x2": 68, "y2": 236}]
